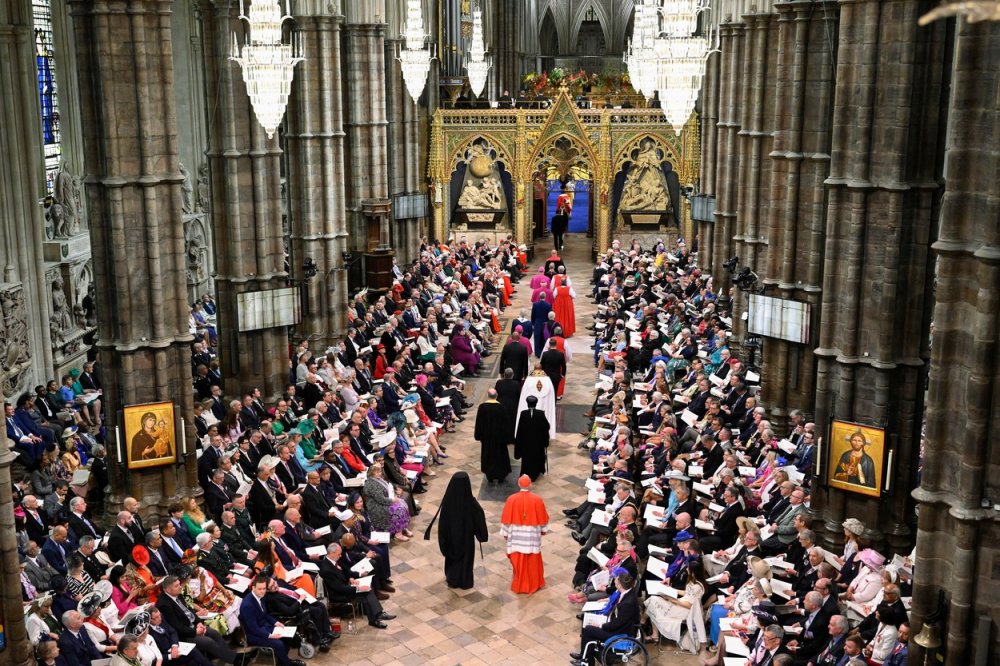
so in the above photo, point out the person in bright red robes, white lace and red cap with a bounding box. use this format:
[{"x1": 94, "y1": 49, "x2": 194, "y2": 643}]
[{"x1": 500, "y1": 474, "x2": 549, "y2": 594}]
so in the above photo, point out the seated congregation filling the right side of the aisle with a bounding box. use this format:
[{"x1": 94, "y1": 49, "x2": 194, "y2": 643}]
[{"x1": 563, "y1": 239, "x2": 913, "y2": 666}]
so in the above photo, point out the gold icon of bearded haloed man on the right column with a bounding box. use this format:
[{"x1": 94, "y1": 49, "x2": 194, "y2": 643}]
[{"x1": 827, "y1": 420, "x2": 886, "y2": 497}]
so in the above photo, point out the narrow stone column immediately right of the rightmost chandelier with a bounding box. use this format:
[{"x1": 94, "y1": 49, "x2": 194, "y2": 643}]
[{"x1": 709, "y1": 18, "x2": 746, "y2": 292}]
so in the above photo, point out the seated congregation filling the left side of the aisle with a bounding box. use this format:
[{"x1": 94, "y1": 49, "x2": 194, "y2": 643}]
[{"x1": 5, "y1": 239, "x2": 532, "y2": 666}]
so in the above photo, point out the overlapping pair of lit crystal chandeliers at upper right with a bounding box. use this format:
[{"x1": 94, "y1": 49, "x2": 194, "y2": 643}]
[{"x1": 626, "y1": 0, "x2": 718, "y2": 133}]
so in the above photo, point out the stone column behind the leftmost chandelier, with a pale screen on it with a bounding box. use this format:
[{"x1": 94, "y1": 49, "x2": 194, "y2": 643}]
[{"x1": 200, "y1": 0, "x2": 288, "y2": 398}]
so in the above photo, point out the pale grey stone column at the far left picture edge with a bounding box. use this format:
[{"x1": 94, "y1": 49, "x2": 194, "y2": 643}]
[{"x1": 0, "y1": 0, "x2": 53, "y2": 396}]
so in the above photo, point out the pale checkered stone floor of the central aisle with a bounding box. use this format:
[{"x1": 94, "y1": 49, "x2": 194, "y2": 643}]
[{"x1": 310, "y1": 234, "x2": 701, "y2": 666}]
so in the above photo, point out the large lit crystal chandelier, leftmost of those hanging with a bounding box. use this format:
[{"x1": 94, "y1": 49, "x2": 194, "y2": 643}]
[{"x1": 229, "y1": 0, "x2": 304, "y2": 139}]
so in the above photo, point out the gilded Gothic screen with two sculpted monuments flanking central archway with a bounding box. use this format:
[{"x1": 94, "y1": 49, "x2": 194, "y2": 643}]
[{"x1": 428, "y1": 89, "x2": 701, "y2": 251}]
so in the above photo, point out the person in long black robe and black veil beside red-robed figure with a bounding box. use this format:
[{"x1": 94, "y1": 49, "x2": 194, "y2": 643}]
[{"x1": 424, "y1": 472, "x2": 490, "y2": 590}]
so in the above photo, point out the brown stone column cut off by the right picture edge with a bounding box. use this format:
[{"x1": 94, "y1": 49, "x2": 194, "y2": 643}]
[{"x1": 910, "y1": 19, "x2": 1000, "y2": 666}]
